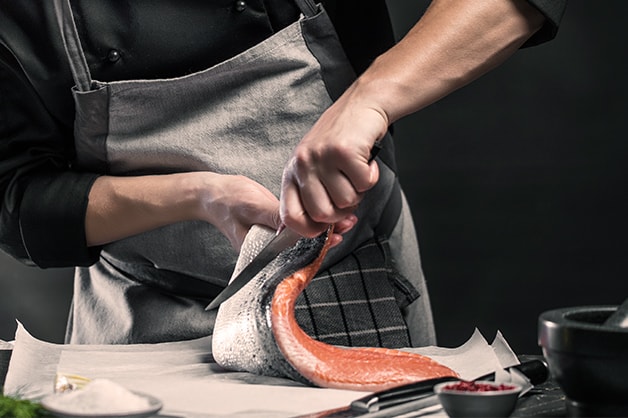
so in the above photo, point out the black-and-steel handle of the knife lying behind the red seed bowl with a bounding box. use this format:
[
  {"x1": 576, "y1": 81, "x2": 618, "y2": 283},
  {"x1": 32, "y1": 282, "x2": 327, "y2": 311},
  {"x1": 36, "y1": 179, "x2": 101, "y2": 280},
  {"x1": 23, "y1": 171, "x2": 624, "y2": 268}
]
[{"x1": 351, "y1": 359, "x2": 549, "y2": 412}]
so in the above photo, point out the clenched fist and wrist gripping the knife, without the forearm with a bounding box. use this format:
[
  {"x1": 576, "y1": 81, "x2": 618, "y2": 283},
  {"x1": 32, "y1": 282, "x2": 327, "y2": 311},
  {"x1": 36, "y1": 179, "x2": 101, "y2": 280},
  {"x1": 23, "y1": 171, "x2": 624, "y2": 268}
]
[{"x1": 280, "y1": 89, "x2": 388, "y2": 243}]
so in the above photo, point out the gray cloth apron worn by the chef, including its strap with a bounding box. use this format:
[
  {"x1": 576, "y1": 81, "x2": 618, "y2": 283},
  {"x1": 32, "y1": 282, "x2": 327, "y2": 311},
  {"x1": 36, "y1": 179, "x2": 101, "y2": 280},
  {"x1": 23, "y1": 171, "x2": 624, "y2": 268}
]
[{"x1": 55, "y1": 0, "x2": 434, "y2": 346}]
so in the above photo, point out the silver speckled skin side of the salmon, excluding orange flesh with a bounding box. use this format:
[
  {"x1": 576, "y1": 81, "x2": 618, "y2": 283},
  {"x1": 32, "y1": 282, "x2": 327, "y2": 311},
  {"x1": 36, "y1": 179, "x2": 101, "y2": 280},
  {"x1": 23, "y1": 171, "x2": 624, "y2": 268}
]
[{"x1": 212, "y1": 226, "x2": 328, "y2": 384}]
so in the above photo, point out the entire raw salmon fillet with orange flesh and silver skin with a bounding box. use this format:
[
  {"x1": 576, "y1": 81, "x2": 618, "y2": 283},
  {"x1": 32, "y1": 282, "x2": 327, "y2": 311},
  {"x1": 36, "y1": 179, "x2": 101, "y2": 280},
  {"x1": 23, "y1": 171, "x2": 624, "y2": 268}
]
[{"x1": 212, "y1": 228, "x2": 457, "y2": 392}]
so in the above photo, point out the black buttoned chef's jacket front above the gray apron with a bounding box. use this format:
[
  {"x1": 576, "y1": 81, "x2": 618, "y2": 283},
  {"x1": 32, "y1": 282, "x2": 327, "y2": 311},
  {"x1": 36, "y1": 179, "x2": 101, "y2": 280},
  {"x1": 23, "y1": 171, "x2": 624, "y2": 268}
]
[{"x1": 57, "y1": 0, "x2": 393, "y2": 81}]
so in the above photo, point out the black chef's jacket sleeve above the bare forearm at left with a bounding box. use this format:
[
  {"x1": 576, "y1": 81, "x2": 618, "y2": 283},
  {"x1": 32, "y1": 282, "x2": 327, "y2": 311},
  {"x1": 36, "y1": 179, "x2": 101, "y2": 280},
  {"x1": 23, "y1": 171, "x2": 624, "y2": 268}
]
[{"x1": 0, "y1": 2, "x2": 98, "y2": 267}]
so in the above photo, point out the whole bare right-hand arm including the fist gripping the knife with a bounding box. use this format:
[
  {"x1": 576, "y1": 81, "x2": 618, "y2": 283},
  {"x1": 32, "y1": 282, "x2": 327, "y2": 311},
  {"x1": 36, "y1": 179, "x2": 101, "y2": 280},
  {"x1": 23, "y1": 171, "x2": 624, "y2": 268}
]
[{"x1": 281, "y1": 0, "x2": 544, "y2": 236}]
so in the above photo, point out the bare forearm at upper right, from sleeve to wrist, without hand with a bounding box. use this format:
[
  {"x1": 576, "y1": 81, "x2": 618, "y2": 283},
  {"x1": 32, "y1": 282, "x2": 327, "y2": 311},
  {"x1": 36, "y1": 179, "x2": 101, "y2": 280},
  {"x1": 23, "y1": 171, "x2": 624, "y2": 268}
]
[{"x1": 347, "y1": 0, "x2": 544, "y2": 124}]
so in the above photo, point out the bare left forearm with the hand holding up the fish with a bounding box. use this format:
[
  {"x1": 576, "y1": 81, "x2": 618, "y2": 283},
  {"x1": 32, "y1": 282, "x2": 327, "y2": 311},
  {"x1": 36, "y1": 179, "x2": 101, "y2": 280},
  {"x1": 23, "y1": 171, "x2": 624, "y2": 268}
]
[{"x1": 85, "y1": 171, "x2": 279, "y2": 249}]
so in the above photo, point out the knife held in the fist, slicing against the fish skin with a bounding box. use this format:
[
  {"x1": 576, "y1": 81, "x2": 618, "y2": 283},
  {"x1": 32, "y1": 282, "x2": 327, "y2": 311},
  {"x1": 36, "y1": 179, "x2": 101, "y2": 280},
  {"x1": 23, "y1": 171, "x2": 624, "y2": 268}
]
[{"x1": 205, "y1": 141, "x2": 382, "y2": 311}]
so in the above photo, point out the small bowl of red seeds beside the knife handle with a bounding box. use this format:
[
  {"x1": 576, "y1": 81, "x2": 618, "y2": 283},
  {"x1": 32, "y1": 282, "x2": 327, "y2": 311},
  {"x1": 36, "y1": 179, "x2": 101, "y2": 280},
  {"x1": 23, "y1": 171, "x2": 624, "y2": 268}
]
[{"x1": 434, "y1": 380, "x2": 522, "y2": 418}]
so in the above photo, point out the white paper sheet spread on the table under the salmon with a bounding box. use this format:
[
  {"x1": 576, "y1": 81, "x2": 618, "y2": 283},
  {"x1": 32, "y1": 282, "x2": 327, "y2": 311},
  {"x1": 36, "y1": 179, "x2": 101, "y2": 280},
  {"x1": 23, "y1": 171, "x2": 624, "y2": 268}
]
[{"x1": 4, "y1": 324, "x2": 517, "y2": 418}]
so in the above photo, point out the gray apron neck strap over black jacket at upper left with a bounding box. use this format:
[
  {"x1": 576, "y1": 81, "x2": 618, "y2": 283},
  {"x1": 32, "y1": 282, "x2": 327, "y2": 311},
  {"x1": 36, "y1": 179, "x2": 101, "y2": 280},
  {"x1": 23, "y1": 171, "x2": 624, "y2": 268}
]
[{"x1": 54, "y1": 0, "x2": 92, "y2": 91}]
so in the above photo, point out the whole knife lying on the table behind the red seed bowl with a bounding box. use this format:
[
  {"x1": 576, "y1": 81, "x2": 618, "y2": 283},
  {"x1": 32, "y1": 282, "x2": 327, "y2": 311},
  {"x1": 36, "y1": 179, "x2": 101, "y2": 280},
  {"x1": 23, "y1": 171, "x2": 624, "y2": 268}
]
[{"x1": 296, "y1": 359, "x2": 549, "y2": 418}]
